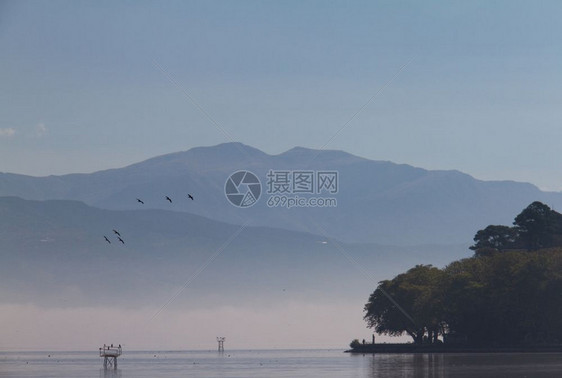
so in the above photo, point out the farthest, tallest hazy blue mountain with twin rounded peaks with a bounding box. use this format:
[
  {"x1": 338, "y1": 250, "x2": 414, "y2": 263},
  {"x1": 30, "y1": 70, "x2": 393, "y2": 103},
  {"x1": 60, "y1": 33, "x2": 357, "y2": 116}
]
[{"x1": 0, "y1": 143, "x2": 562, "y2": 245}]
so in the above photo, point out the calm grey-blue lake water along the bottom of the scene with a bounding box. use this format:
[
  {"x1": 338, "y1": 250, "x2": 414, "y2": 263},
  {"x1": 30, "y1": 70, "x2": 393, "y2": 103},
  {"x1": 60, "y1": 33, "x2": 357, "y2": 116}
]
[{"x1": 0, "y1": 350, "x2": 562, "y2": 378}]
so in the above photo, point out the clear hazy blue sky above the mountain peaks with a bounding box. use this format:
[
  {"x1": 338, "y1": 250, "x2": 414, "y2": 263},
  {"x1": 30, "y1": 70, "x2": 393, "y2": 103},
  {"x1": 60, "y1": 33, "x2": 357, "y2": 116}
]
[{"x1": 0, "y1": 0, "x2": 562, "y2": 190}]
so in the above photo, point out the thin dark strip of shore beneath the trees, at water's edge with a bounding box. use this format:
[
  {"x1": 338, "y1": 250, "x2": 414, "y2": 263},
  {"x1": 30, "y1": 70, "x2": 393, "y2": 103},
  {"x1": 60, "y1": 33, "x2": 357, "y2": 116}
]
[{"x1": 345, "y1": 344, "x2": 562, "y2": 354}]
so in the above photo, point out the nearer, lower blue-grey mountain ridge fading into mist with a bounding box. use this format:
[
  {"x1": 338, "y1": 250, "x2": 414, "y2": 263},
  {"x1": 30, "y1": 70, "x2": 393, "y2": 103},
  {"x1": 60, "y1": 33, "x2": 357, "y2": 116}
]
[{"x1": 0, "y1": 197, "x2": 464, "y2": 308}]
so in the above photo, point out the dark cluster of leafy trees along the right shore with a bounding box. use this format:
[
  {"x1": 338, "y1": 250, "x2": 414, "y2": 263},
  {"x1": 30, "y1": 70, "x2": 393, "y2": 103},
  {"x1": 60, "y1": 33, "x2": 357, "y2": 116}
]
[{"x1": 364, "y1": 202, "x2": 562, "y2": 345}]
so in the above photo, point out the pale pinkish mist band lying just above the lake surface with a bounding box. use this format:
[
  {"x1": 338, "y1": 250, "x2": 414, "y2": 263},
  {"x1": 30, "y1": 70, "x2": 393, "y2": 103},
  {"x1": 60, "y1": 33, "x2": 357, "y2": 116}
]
[{"x1": 0, "y1": 302, "x2": 406, "y2": 351}]
